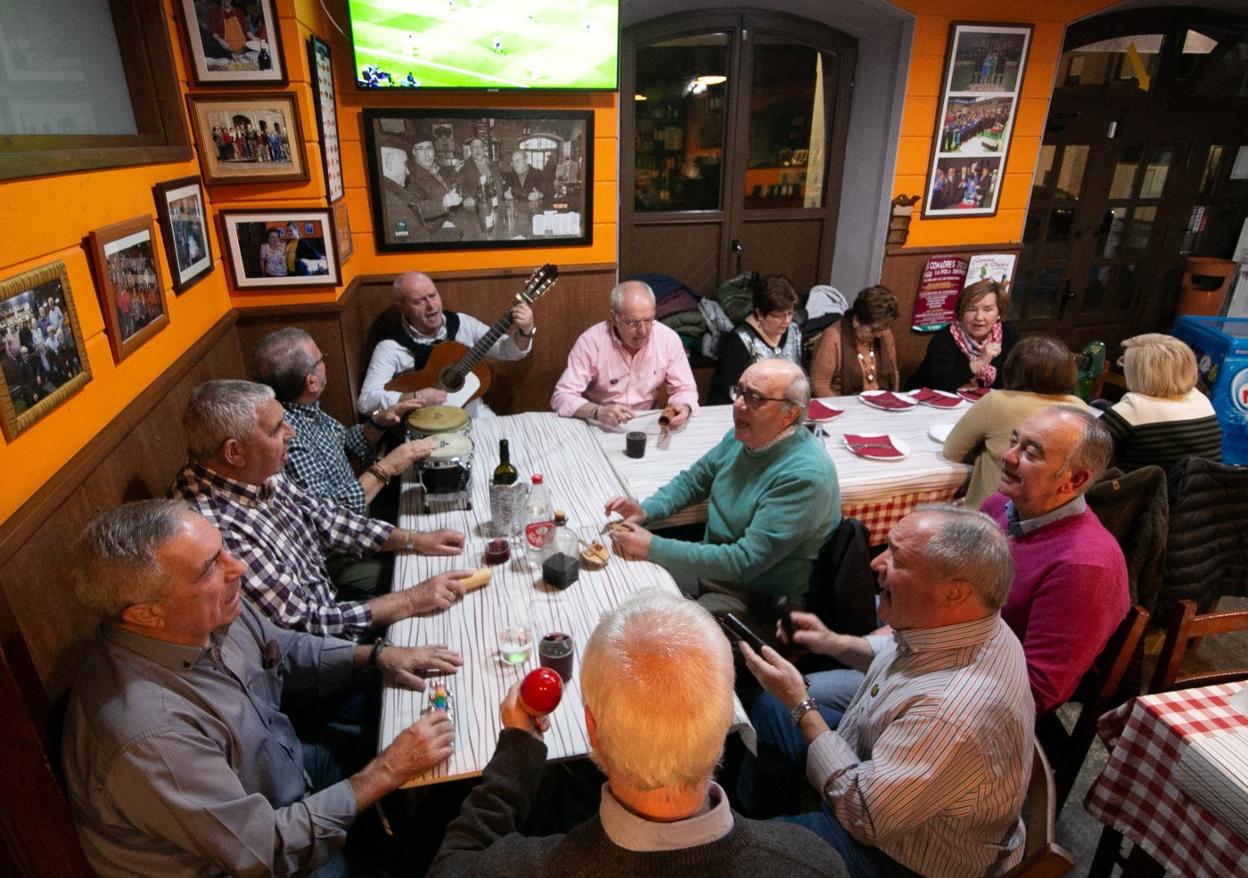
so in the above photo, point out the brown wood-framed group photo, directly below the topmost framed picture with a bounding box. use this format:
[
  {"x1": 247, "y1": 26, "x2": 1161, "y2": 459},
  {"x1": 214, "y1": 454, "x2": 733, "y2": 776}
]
[{"x1": 186, "y1": 91, "x2": 308, "y2": 186}]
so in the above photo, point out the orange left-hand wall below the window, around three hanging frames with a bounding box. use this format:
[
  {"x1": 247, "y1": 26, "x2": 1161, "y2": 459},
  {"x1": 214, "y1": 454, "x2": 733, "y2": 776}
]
[{"x1": 0, "y1": 0, "x2": 231, "y2": 521}]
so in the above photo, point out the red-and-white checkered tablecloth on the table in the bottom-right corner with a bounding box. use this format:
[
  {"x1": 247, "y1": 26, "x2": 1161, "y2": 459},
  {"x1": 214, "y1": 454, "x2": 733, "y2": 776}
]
[{"x1": 1085, "y1": 683, "x2": 1248, "y2": 878}]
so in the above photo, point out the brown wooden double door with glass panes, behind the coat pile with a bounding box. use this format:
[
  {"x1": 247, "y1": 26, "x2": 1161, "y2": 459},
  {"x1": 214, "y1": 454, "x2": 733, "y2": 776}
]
[{"x1": 620, "y1": 12, "x2": 856, "y2": 293}]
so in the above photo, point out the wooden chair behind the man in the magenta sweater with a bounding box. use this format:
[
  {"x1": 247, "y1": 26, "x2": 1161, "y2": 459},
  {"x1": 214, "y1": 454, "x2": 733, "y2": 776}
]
[{"x1": 1036, "y1": 604, "x2": 1148, "y2": 812}]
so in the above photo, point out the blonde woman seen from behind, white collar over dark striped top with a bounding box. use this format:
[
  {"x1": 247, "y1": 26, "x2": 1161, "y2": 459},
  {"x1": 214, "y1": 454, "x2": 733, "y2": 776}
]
[{"x1": 1101, "y1": 333, "x2": 1222, "y2": 473}]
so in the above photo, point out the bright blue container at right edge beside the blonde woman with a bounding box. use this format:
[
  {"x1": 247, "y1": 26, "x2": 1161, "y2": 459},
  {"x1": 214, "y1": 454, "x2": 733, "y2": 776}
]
[{"x1": 1171, "y1": 317, "x2": 1248, "y2": 466}]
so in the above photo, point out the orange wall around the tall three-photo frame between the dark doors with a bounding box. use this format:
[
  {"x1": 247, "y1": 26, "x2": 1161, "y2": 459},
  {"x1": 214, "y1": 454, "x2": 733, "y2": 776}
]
[{"x1": 892, "y1": 0, "x2": 1114, "y2": 247}]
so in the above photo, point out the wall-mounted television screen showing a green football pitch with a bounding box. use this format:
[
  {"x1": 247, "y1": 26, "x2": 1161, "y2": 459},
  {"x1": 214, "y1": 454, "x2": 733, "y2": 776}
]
[{"x1": 347, "y1": 0, "x2": 619, "y2": 90}]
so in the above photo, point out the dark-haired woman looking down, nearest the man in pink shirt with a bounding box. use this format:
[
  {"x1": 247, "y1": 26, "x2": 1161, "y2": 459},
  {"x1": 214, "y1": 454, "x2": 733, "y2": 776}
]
[{"x1": 706, "y1": 274, "x2": 801, "y2": 405}]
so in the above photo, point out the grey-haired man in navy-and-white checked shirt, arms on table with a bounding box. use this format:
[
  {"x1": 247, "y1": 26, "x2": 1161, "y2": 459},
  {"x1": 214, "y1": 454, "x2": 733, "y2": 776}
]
[{"x1": 170, "y1": 380, "x2": 470, "y2": 649}]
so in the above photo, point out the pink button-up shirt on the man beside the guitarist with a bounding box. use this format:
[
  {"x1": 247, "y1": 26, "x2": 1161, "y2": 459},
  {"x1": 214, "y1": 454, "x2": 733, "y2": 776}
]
[{"x1": 550, "y1": 321, "x2": 698, "y2": 418}]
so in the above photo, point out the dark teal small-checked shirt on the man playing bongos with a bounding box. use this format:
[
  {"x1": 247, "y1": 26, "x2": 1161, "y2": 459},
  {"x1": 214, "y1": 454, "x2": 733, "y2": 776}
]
[{"x1": 282, "y1": 403, "x2": 376, "y2": 515}]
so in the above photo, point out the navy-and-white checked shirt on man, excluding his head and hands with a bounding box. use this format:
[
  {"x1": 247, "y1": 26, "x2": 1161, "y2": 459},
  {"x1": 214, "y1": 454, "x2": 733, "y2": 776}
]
[{"x1": 170, "y1": 463, "x2": 393, "y2": 640}]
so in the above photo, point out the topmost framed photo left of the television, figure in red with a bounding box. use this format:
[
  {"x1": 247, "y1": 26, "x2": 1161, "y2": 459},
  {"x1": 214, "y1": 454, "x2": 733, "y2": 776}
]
[{"x1": 175, "y1": 0, "x2": 286, "y2": 85}]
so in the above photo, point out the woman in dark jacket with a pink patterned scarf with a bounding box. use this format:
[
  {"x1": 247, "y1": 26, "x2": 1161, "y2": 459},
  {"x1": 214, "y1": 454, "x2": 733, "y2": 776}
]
[{"x1": 906, "y1": 278, "x2": 1018, "y2": 392}]
